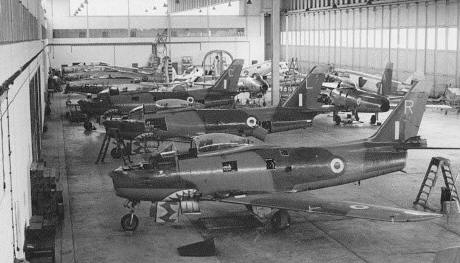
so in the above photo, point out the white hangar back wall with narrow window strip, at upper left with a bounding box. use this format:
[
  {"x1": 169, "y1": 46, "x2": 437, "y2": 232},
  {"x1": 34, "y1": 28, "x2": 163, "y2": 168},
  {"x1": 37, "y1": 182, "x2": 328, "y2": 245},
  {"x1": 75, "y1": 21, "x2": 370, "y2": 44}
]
[{"x1": 46, "y1": 0, "x2": 264, "y2": 67}]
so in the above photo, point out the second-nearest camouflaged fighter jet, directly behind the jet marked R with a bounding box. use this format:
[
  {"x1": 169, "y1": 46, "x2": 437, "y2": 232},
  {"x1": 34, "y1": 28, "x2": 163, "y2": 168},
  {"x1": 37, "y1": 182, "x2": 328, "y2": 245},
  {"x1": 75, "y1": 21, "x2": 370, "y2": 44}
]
[{"x1": 103, "y1": 68, "x2": 330, "y2": 145}]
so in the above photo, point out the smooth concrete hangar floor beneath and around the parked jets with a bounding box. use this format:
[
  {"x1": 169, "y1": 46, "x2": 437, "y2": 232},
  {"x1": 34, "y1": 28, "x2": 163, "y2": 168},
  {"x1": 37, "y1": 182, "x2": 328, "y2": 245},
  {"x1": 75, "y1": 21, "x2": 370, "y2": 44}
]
[{"x1": 44, "y1": 94, "x2": 460, "y2": 263}]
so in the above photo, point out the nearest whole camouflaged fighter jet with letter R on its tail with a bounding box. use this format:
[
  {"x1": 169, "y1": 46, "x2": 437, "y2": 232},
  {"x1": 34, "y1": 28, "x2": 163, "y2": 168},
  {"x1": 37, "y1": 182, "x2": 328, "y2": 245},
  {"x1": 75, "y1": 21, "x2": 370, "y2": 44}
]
[{"x1": 111, "y1": 77, "x2": 440, "y2": 231}]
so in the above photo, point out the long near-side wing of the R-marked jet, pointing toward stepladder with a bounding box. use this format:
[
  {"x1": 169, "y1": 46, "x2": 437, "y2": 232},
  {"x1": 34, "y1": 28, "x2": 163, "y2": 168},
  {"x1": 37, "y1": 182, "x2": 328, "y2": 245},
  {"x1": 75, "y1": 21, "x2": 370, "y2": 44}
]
[{"x1": 220, "y1": 193, "x2": 441, "y2": 222}]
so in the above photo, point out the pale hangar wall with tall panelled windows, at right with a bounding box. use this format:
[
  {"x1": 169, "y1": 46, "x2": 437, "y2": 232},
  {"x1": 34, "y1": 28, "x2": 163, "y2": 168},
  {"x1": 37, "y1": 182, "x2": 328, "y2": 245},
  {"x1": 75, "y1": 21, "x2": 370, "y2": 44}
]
[{"x1": 281, "y1": 0, "x2": 460, "y2": 94}]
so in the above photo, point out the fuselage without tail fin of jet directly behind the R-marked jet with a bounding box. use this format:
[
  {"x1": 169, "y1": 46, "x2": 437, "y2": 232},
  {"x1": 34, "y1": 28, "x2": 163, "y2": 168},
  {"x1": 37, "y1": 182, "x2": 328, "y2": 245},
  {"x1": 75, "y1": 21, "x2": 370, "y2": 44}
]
[{"x1": 104, "y1": 107, "x2": 322, "y2": 139}]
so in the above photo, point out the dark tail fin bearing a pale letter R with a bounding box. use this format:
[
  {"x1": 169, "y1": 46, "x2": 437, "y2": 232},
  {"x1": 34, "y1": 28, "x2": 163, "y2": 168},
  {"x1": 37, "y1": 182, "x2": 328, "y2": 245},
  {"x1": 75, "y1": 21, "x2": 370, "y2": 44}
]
[{"x1": 370, "y1": 81, "x2": 430, "y2": 142}]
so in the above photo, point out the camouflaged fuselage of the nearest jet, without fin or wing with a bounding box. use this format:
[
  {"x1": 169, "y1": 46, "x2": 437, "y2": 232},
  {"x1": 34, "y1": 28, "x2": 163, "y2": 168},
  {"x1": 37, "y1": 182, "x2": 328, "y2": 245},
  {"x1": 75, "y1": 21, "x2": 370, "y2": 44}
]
[{"x1": 112, "y1": 140, "x2": 407, "y2": 201}]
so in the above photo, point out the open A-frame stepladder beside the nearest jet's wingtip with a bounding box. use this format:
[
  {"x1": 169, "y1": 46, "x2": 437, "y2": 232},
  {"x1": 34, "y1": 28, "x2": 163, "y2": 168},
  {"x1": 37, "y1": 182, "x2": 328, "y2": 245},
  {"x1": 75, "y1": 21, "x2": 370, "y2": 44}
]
[{"x1": 413, "y1": 156, "x2": 459, "y2": 210}]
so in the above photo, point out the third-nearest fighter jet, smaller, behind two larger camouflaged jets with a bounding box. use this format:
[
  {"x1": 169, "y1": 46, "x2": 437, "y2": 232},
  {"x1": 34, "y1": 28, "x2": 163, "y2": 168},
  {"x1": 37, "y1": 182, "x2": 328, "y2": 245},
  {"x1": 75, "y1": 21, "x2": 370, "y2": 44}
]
[{"x1": 78, "y1": 59, "x2": 243, "y2": 116}]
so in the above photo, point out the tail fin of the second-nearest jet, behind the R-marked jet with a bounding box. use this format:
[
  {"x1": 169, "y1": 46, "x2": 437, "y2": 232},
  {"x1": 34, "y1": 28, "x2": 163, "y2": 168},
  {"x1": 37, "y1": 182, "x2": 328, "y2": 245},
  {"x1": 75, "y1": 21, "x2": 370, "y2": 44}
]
[{"x1": 282, "y1": 69, "x2": 326, "y2": 108}]
